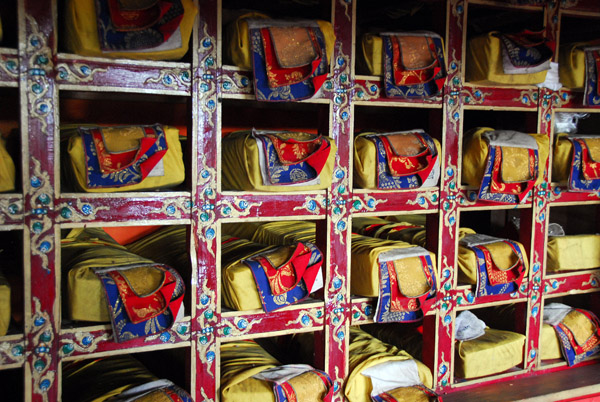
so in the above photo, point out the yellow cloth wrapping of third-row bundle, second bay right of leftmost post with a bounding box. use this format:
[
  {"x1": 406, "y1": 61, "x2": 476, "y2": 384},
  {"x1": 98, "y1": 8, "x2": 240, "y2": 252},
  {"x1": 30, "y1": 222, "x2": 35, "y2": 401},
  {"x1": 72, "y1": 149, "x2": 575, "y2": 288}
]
[{"x1": 221, "y1": 236, "x2": 272, "y2": 310}]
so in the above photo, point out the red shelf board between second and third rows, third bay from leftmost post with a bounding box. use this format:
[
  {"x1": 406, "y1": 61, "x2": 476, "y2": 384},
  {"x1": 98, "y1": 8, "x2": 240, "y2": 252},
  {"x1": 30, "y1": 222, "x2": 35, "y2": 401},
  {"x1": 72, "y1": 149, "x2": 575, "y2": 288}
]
[{"x1": 351, "y1": 188, "x2": 440, "y2": 213}]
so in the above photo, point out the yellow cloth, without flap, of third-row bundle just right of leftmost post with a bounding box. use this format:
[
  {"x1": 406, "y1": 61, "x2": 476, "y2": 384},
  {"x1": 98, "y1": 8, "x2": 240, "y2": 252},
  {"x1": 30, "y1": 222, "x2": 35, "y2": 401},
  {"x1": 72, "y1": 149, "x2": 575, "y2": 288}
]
[{"x1": 61, "y1": 228, "x2": 152, "y2": 322}]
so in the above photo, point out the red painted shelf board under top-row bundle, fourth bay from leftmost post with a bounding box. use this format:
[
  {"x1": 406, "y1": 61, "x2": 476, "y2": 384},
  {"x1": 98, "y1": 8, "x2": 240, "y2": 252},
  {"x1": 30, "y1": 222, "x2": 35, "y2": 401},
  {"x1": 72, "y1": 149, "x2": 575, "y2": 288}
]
[{"x1": 462, "y1": 82, "x2": 539, "y2": 112}]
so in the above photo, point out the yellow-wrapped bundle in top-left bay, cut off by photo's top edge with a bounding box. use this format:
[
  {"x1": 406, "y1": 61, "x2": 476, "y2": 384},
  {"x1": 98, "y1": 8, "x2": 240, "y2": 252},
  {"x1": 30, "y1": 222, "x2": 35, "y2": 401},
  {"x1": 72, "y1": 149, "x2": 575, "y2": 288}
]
[{"x1": 65, "y1": 0, "x2": 197, "y2": 60}]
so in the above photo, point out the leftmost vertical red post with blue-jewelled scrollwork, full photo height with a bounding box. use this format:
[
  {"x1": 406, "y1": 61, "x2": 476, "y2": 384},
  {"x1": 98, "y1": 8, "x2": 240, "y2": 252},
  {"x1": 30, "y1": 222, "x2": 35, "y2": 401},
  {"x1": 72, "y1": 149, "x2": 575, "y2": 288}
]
[{"x1": 18, "y1": 0, "x2": 60, "y2": 401}]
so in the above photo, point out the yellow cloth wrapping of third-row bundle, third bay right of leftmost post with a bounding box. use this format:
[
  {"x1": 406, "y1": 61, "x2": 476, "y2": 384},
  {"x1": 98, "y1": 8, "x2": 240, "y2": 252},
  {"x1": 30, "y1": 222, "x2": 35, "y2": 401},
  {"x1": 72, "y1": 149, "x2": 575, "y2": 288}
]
[{"x1": 350, "y1": 235, "x2": 439, "y2": 297}]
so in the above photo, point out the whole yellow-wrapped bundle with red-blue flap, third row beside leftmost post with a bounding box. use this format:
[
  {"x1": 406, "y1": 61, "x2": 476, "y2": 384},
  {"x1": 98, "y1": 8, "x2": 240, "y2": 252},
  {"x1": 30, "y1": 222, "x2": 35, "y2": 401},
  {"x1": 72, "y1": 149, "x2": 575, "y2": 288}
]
[{"x1": 62, "y1": 228, "x2": 185, "y2": 342}]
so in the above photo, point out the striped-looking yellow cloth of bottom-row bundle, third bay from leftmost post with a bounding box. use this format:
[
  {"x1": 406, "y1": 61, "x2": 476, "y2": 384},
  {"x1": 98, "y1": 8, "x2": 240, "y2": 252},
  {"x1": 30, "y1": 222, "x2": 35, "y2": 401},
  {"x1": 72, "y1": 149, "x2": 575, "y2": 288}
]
[{"x1": 344, "y1": 327, "x2": 433, "y2": 402}]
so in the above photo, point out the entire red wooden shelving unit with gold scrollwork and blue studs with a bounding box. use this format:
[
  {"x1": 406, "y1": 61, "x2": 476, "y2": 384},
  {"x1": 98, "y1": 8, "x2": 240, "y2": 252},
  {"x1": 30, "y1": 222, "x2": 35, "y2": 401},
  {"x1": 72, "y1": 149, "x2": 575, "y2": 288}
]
[{"x1": 0, "y1": 0, "x2": 600, "y2": 401}]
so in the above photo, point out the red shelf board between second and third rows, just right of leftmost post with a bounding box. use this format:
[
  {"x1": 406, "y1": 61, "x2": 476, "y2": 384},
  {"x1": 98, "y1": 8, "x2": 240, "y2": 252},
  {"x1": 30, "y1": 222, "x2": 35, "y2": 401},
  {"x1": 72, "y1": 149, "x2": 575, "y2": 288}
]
[{"x1": 54, "y1": 192, "x2": 192, "y2": 226}]
